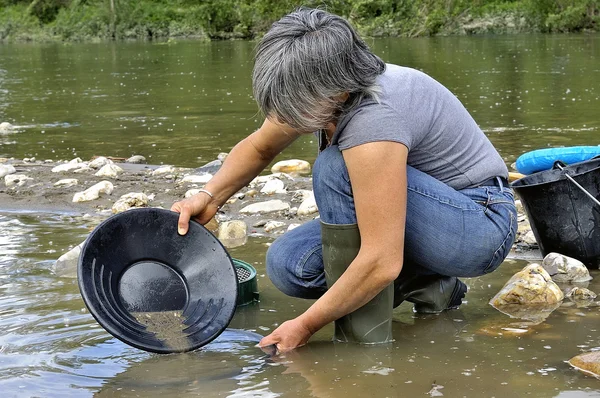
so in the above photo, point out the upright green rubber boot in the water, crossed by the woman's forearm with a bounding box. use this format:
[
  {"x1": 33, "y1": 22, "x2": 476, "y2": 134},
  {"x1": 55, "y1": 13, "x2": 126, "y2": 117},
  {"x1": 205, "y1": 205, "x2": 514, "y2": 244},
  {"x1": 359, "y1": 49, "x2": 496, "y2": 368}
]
[{"x1": 321, "y1": 221, "x2": 394, "y2": 344}]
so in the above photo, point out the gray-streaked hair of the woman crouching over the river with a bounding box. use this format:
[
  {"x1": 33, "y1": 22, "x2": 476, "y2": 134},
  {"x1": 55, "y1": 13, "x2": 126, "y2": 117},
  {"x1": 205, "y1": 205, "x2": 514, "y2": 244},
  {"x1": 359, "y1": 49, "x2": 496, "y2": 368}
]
[{"x1": 252, "y1": 9, "x2": 385, "y2": 131}]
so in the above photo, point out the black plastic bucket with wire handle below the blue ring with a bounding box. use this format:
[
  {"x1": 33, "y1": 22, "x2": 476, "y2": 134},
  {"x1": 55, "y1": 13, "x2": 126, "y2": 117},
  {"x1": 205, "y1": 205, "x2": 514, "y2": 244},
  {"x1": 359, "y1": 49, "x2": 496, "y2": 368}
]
[{"x1": 511, "y1": 159, "x2": 600, "y2": 268}]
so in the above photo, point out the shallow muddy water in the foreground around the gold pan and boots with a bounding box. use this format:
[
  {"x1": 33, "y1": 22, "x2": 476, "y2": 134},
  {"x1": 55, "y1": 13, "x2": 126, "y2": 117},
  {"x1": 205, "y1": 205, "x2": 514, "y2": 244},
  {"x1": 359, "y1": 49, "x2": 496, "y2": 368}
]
[{"x1": 0, "y1": 213, "x2": 600, "y2": 397}]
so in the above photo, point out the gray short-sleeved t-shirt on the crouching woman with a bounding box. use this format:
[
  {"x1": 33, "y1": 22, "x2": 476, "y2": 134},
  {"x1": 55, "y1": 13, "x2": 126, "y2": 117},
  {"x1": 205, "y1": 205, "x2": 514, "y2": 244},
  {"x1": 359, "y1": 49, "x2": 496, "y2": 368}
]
[{"x1": 332, "y1": 64, "x2": 508, "y2": 189}]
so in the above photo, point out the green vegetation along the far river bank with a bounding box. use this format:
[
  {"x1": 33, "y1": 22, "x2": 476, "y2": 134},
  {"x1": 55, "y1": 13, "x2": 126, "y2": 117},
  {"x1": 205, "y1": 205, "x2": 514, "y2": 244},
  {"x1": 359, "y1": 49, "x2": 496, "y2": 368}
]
[{"x1": 0, "y1": 0, "x2": 600, "y2": 40}]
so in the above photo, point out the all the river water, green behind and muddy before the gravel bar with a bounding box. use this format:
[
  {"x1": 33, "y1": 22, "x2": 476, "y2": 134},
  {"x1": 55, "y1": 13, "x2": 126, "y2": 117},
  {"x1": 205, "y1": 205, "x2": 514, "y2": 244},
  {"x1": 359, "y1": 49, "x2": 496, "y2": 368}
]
[{"x1": 0, "y1": 35, "x2": 600, "y2": 397}]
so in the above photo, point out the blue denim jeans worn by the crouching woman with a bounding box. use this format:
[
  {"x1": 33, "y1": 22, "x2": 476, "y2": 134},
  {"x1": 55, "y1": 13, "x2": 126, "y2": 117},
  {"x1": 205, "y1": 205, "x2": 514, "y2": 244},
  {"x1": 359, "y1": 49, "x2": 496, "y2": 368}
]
[{"x1": 267, "y1": 146, "x2": 517, "y2": 299}]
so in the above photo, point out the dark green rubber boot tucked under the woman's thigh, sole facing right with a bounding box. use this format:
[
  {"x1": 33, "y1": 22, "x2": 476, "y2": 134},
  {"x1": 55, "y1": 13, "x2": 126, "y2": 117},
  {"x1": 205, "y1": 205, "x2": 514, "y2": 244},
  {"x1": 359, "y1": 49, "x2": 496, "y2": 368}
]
[{"x1": 394, "y1": 273, "x2": 467, "y2": 314}]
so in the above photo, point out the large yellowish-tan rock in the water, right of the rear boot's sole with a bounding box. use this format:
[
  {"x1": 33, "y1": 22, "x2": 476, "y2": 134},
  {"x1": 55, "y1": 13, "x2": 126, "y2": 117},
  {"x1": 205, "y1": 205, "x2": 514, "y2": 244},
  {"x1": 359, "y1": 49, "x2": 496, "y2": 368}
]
[{"x1": 490, "y1": 264, "x2": 564, "y2": 307}]
